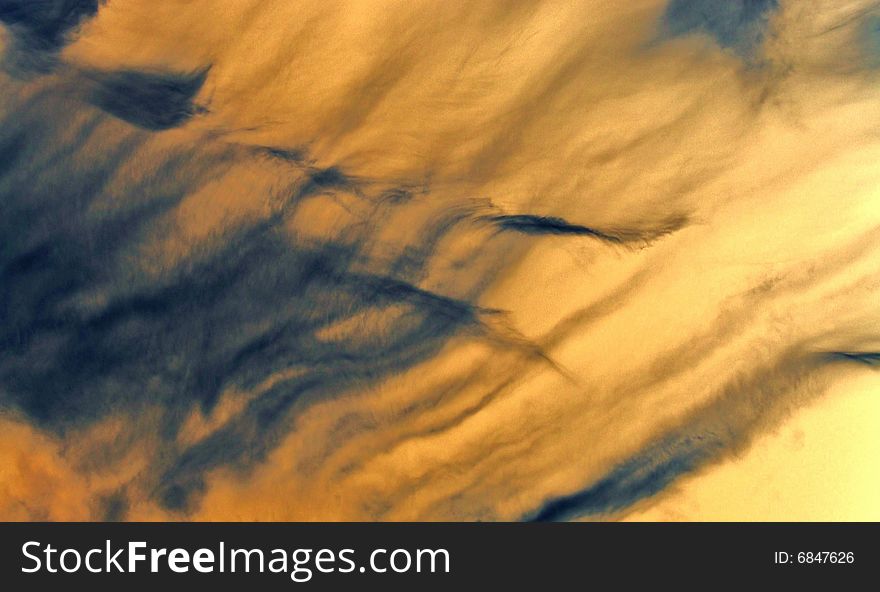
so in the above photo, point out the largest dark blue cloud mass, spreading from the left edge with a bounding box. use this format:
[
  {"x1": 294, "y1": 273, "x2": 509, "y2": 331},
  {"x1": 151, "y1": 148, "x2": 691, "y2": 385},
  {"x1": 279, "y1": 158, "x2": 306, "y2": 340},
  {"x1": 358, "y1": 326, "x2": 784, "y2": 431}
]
[{"x1": 0, "y1": 75, "x2": 496, "y2": 517}]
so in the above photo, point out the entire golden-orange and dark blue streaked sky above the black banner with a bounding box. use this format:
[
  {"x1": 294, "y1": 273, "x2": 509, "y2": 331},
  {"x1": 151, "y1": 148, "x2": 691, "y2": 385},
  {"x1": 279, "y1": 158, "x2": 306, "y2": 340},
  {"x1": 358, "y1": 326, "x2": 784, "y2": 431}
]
[{"x1": 0, "y1": 0, "x2": 880, "y2": 521}]
